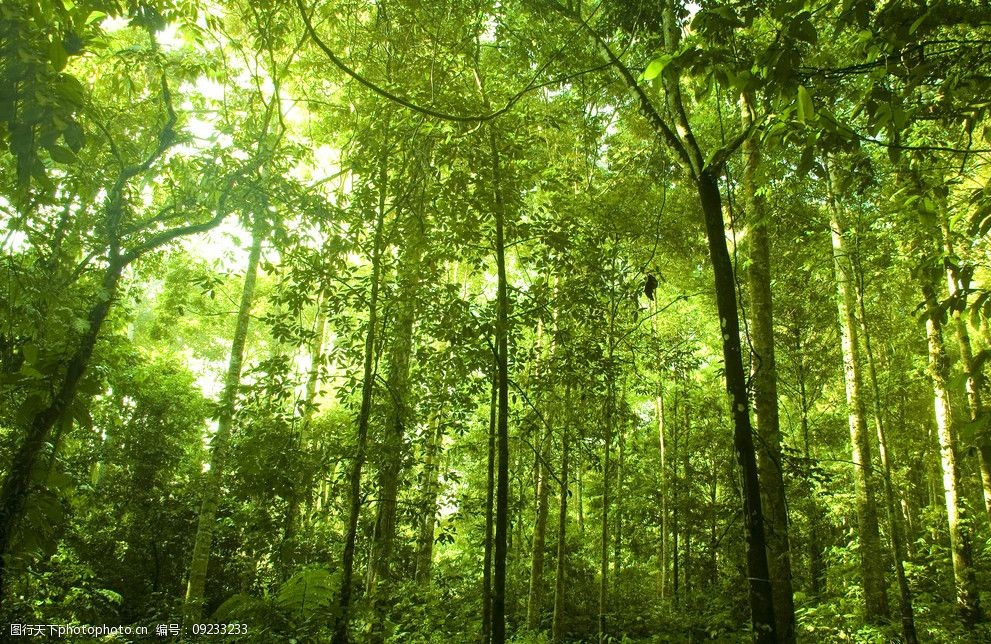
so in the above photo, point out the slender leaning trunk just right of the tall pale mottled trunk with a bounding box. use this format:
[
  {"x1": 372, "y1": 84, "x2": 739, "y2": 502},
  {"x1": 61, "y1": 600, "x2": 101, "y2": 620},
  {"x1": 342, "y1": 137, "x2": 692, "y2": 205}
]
[{"x1": 854, "y1": 262, "x2": 919, "y2": 644}]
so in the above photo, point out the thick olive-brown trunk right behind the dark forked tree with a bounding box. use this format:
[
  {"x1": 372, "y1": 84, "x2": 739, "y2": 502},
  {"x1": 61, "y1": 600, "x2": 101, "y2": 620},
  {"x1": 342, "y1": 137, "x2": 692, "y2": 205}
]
[{"x1": 740, "y1": 93, "x2": 795, "y2": 644}]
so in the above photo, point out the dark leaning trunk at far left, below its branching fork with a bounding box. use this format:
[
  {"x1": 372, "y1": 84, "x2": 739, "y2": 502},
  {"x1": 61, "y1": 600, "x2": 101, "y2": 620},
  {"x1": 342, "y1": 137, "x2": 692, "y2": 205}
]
[{"x1": 0, "y1": 260, "x2": 124, "y2": 607}]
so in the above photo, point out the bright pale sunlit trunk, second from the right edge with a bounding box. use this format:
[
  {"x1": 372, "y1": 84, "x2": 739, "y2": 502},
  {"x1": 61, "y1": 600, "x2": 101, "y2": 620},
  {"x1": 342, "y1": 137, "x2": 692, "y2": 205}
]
[{"x1": 918, "y1": 266, "x2": 983, "y2": 624}]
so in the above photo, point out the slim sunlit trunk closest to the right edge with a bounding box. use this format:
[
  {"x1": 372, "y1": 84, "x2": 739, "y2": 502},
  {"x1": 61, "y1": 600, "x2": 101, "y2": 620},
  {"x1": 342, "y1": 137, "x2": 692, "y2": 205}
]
[{"x1": 940, "y1": 213, "x2": 991, "y2": 523}]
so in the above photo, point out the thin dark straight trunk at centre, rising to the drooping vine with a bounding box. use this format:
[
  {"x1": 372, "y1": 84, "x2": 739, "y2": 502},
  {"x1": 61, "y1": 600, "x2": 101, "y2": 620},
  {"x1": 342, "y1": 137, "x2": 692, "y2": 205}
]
[{"x1": 486, "y1": 122, "x2": 509, "y2": 644}]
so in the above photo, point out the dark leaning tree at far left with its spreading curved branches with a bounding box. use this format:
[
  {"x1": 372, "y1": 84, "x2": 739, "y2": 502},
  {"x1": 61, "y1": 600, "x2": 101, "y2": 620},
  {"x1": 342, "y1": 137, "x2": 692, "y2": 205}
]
[{"x1": 0, "y1": 20, "x2": 270, "y2": 598}]
